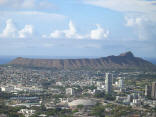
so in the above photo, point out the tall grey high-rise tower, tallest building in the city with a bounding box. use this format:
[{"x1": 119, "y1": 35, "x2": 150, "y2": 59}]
[{"x1": 105, "y1": 73, "x2": 112, "y2": 94}]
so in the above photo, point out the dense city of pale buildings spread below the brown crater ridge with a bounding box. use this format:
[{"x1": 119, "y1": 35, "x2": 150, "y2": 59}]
[{"x1": 0, "y1": 67, "x2": 156, "y2": 116}]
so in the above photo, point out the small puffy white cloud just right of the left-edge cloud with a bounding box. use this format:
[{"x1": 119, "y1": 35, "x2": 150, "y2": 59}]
[{"x1": 18, "y1": 25, "x2": 33, "y2": 38}]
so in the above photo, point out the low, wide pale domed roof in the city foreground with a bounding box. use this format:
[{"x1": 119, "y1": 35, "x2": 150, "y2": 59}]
[{"x1": 68, "y1": 99, "x2": 96, "y2": 107}]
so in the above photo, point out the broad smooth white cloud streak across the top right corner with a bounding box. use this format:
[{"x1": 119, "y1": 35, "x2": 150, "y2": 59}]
[{"x1": 83, "y1": 0, "x2": 156, "y2": 21}]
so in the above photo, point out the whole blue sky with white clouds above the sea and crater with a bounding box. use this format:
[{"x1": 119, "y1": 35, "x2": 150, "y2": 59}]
[{"x1": 0, "y1": 0, "x2": 156, "y2": 58}]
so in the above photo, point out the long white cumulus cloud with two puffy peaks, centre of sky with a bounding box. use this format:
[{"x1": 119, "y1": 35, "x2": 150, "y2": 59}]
[{"x1": 42, "y1": 21, "x2": 109, "y2": 40}]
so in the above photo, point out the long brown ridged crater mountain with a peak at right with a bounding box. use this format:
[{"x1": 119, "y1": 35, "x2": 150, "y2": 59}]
[{"x1": 9, "y1": 52, "x2": 156, "y2": 70}]
